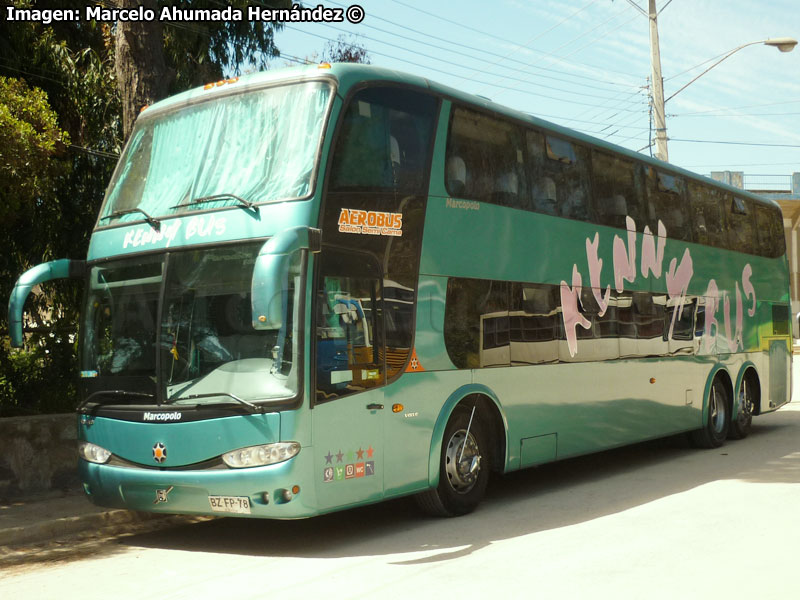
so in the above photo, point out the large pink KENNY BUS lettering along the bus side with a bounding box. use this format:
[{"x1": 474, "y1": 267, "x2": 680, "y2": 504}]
[{"x1": 561, "y1": 217, "x2": 756, "y2": 356}]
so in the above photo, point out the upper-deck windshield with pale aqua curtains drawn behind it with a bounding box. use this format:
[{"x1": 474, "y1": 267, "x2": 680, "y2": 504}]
[{"x1": 100, "y1": 81, "x2": 331, "y2": 225}]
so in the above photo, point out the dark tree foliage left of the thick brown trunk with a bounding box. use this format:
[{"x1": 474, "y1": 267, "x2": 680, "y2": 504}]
[{"x1": 0, "y1": 0, "x2": 120, "y2": 415}]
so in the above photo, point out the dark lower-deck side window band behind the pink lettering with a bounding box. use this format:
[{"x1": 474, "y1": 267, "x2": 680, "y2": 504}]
[{"x1": 444, "y1": 278, "x2": 704, "y2": 369}]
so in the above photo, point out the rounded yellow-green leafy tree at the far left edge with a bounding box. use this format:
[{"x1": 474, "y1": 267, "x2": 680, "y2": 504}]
[{"x1": 0, "y1": 71, "x2": 98, "y2": 415}]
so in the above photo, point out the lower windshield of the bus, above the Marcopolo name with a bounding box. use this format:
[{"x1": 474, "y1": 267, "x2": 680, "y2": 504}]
[{"x1": 81, "y1": 242, "x2": 299, "y2": 405}]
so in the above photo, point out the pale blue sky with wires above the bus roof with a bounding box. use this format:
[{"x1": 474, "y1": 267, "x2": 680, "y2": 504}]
[{"x1": 274, "y1": 0, "x2": 800, "y2": 184}]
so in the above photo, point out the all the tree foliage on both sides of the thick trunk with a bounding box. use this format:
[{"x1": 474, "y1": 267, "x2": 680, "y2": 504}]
[{"x1": 0, "y1": 0, "x2": 291, "y2": 416}]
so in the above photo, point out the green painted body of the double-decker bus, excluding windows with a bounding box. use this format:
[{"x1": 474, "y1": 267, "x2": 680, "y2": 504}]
[{"x1": 9, "y1": 65, "x2": 791, "y2": 518}]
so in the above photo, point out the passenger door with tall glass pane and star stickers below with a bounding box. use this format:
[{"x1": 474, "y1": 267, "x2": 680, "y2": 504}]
[{"x1": 312, "y1": 248, "x2": 386, "y2": 509}]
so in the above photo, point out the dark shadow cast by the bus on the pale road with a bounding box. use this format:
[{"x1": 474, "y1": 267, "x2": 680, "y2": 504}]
[{"x1": 119, "y1": 411, "x2": 800, "y2": 565}]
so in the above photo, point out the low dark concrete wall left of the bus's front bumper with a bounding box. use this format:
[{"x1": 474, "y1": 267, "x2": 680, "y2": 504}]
[{"x1": 0, "y1": 413, "x2": 80, "y2": 499}]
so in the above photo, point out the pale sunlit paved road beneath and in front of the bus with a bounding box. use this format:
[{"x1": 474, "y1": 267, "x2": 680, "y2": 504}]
[{"x1": 0, "y1": 379, "x2": 800, "y2": 600}]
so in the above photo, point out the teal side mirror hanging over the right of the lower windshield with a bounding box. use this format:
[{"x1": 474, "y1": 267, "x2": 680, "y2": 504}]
[{"x1": 250, "y1": 227, "x2": 322, "y2": 330}]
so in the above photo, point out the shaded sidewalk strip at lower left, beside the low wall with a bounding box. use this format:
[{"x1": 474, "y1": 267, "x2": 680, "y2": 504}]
[{"x1": 0, "y1": 491, "x2": 170, "y2": 555}]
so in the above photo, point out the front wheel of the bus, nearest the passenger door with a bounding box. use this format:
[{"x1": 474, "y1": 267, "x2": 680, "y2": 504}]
[{"x1": 416, "y1": 408, "x2": 491, "y2": 517}]
